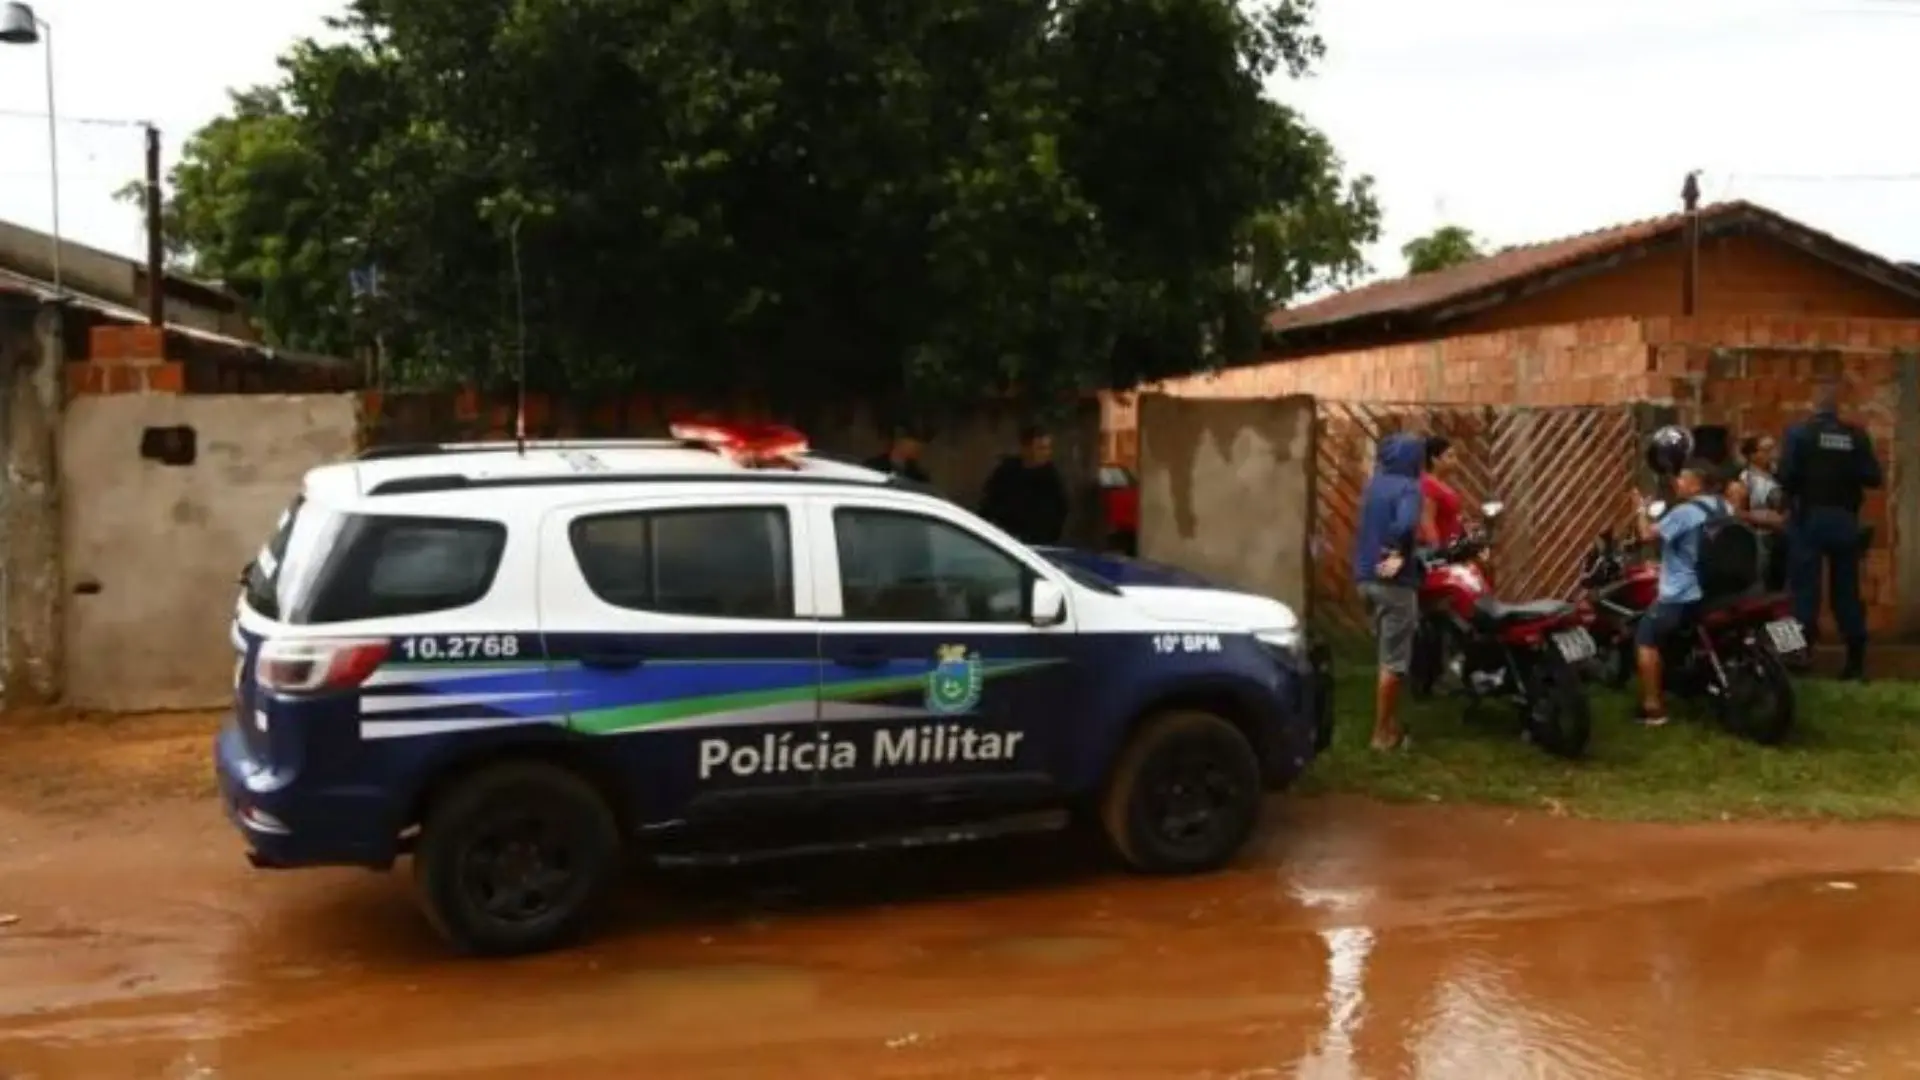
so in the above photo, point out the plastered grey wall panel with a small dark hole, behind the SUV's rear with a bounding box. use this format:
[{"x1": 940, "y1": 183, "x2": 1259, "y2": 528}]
[{"x1": 60, "y1": 394, "x2": 357, "y2": 711}]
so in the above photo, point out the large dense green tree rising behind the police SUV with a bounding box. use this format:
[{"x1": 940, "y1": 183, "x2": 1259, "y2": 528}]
[{"x1": 167, "y1": 0, "x2": 1379, "y2": 394}]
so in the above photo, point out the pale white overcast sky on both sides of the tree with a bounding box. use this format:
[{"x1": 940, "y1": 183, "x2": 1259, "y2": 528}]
[{"x1": 0, "y1": 0, "x2": 1920, "y2": 282}]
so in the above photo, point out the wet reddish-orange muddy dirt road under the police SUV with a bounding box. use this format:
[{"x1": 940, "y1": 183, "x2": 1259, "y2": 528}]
[{"x1": 0, "y1": 719, "x2": 1920, "y2": 1080}]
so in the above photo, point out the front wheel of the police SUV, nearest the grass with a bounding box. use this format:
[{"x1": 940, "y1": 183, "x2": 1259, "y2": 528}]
[{"x1": 1100, "y1": 709, "x2": 1265, "y2": 874}]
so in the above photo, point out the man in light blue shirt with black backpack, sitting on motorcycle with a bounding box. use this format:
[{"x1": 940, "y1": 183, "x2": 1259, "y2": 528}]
[{"x1": 1634, "y1": 457, "x2": 1761, "y2": 726}]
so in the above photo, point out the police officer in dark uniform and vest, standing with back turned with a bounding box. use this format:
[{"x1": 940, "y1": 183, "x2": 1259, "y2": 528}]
[{"x1": 1778, "y1": 380, "x2": 1884, "y2": 680}]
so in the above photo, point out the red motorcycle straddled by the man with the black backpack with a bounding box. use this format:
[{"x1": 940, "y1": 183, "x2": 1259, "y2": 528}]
[{"x1": 1580, "y1": 502, "x2": 1807, "y2": 746}]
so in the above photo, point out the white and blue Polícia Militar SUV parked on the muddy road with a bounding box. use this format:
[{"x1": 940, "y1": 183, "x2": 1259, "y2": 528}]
[{"x1": 215, "y1": 425, "x2": 1331, "y2": 953}]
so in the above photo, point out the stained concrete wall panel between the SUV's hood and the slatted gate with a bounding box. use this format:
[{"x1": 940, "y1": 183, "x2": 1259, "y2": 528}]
[{"x1": 1140, "y1": 394, "x2": 1313, "y2": 617}]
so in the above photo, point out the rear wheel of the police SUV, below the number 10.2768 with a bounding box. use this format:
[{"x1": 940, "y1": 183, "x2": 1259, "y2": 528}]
[{"x1": 413, "y1": 761, "x2": 620, "y2": 957}]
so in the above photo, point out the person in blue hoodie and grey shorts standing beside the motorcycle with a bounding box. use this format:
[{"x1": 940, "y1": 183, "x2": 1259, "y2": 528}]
[{"x1": 1354, "y1": 432, "x2": 1427, "y2": 749}]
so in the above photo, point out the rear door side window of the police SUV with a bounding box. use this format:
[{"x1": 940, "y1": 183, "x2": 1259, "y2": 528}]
[{"x1": 568, "y1": 507, "x2": 793, "y2": 619}]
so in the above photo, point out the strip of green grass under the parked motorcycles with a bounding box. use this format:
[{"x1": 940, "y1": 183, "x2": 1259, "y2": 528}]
[{"x1": 1300, "y1": 665, "x2": 1920, "y2": 821}]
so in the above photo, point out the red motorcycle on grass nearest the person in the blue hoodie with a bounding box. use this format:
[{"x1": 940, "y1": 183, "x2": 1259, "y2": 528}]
[{"x1": 1409, "y1": 502, "x2": 1599, "y2": 757}]
